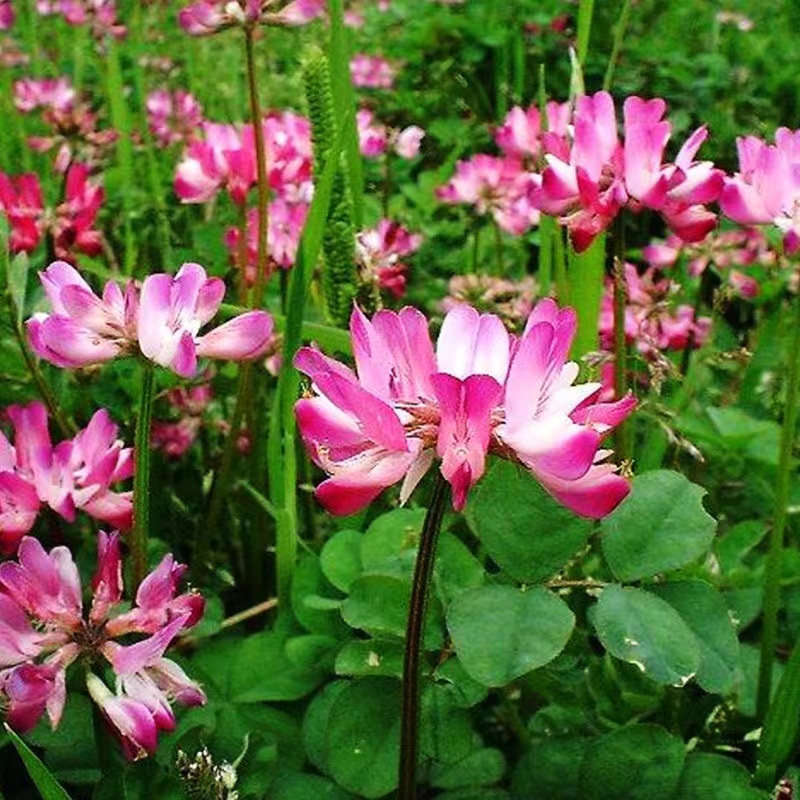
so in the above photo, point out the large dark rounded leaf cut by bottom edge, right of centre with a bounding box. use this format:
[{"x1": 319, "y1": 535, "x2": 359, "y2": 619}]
[{"x1": 580, "y1": 725, "x2": 684, "y2": 800}]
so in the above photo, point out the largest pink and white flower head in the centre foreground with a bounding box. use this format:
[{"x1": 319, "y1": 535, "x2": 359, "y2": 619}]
[{"x1": 295, "y1": 299, "x2": 635, "y2": 517}]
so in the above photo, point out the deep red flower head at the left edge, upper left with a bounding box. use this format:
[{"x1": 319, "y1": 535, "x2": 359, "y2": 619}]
[{"x1": 0, "y1": 163, "x2": 104, "y2": 260}]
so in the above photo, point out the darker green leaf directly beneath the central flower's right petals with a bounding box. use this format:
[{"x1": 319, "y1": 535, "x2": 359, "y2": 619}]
[{"x1": 466, "y1": 461, "x2": 593, "y2": 583}]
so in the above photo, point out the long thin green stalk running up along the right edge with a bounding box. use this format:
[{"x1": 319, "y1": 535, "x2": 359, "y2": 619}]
[{"x1": 756, "y1": 286, "x2": 800, "y2": 720}]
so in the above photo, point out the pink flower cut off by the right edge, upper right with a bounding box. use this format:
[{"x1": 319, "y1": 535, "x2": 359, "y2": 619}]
[{"x1": 720, "y1": 128, "x2": 800, "y2": 255}]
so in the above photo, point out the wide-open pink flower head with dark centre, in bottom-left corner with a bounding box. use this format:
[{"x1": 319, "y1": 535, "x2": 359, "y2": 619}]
[{"x1": 0, "y1": 532, "x2": 205, "y2": 760}]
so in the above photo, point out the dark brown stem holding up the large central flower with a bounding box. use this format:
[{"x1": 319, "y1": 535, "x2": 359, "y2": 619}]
[{"x1": 397, "y1": 472, "x2": 448, "y2": 800}]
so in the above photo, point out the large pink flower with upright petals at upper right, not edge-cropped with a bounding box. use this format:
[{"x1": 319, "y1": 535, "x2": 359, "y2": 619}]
[{"x1": 537, "y1": 92, "x2": 722, "y2": 251}]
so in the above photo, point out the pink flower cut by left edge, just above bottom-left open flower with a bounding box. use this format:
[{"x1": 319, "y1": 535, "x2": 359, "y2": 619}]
[{"x1": 0, "y1": 402, "x2": 133, "y2": 555}]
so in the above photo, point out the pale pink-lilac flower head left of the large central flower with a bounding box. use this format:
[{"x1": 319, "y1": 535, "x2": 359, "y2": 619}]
[{"x1": 27, "y1": 261, "x2": 272, "y2": 377}]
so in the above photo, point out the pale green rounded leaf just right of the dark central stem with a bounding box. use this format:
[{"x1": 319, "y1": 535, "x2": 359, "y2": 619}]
[{"x1": 447, "y1": 586, "x2": 575, "y2": 686}]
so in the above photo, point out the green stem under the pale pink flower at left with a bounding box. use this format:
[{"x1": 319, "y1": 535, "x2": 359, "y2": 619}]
[{"x1": 131, "y1": 361, "x2": 155, "y2": 591}]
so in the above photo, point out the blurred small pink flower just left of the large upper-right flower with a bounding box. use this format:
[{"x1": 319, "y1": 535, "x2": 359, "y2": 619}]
[{"x1": 436, "y1": 155, "x2": 539, "y2": 236}]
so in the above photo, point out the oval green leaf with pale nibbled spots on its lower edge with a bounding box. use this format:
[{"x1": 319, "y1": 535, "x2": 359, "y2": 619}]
[{"x1": 593, "y1": 585, "x2": 700, "y2": 686}]
